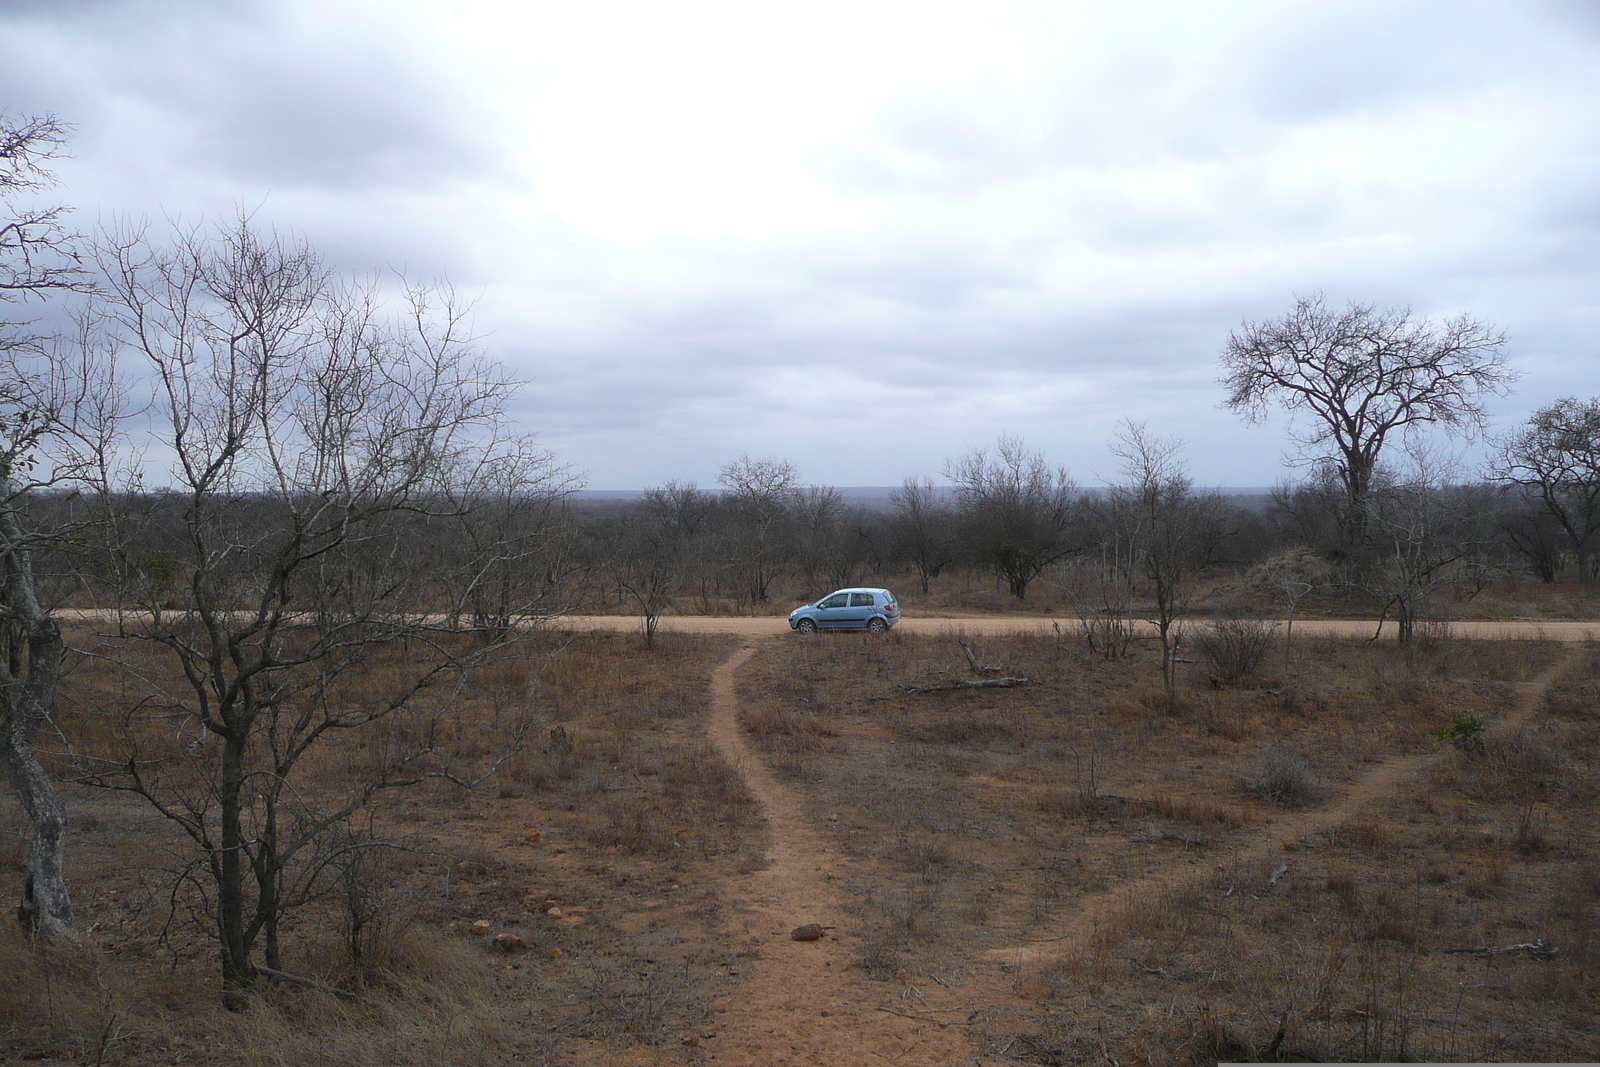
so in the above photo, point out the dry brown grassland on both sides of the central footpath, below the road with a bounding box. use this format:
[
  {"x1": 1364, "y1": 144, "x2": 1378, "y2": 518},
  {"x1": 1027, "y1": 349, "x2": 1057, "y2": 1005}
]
[{"x1": 0, "y1": 627, "x2": 1600, "y2": 1067}]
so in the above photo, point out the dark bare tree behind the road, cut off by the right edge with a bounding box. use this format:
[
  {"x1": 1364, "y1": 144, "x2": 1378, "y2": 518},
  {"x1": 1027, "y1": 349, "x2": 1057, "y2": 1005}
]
[{"x1": 1493, "y1": 397, "x2": 1600, "y2": 581}]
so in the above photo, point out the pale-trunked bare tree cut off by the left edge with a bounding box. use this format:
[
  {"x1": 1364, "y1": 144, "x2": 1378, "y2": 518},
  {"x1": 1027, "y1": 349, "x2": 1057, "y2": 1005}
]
[{"x1": 0, "y1": 114, "x2": 100, "y2": 939}]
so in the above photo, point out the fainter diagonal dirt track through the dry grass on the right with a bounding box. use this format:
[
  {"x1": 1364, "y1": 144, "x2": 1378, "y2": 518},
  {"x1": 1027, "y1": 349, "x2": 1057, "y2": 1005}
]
[{"x1": 984, "y1": 648, "x2": 1584, "y2": 968}]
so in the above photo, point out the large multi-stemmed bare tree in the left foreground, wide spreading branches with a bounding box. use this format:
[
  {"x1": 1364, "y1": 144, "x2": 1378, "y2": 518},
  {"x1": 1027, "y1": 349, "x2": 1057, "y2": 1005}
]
[{"x1": 75, "y1": 218, "x2": 566, "y2": 1006}]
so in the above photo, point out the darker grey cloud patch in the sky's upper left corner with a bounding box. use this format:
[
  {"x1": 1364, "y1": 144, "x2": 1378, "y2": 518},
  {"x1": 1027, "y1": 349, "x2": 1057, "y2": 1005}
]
[{"x1": 0, "y1": 2, "x2": 496, "y2": 192}]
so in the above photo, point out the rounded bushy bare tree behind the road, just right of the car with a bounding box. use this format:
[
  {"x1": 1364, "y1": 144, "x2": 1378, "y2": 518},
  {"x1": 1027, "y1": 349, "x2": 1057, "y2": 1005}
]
[{"x1": 944, "y1": 437, "x2": 1078, "y2": 600}]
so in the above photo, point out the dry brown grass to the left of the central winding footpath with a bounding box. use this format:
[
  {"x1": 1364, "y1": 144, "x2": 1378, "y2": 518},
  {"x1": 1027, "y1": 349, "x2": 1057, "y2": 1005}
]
[{"x1": 0, "y1": 635, "x2": 762, "y2": 1067}]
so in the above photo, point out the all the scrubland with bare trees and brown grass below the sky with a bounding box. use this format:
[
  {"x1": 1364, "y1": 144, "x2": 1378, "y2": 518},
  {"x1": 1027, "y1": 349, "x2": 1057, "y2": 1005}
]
[{"x1": 0, "y1": 115, "x2": 1600, "y2": 1065}]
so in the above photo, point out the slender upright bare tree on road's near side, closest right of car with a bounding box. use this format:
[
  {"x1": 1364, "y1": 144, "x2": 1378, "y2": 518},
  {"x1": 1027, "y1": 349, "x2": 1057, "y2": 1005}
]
[{"x1": 1107, "y1": 422, "x2": 1222, "y2": 704}]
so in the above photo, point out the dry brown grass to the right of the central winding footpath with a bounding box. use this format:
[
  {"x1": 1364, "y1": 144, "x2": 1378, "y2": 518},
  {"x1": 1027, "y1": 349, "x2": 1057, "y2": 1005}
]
[{"x1": 741, "y1": 635, "x2": 1600, "y2": 1064}]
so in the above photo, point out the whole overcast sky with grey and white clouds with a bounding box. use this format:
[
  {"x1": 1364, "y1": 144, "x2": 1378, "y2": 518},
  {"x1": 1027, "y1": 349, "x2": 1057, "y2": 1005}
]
[{"x1": 0, "y1": 0, "x2": 1600, "y2": 488}]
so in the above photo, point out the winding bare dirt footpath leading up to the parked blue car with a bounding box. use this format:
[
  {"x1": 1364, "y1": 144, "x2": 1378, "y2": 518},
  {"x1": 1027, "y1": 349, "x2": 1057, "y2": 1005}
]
[{"x1": 709, "y1": 643, "x2": 971, "y2": 1067}]
